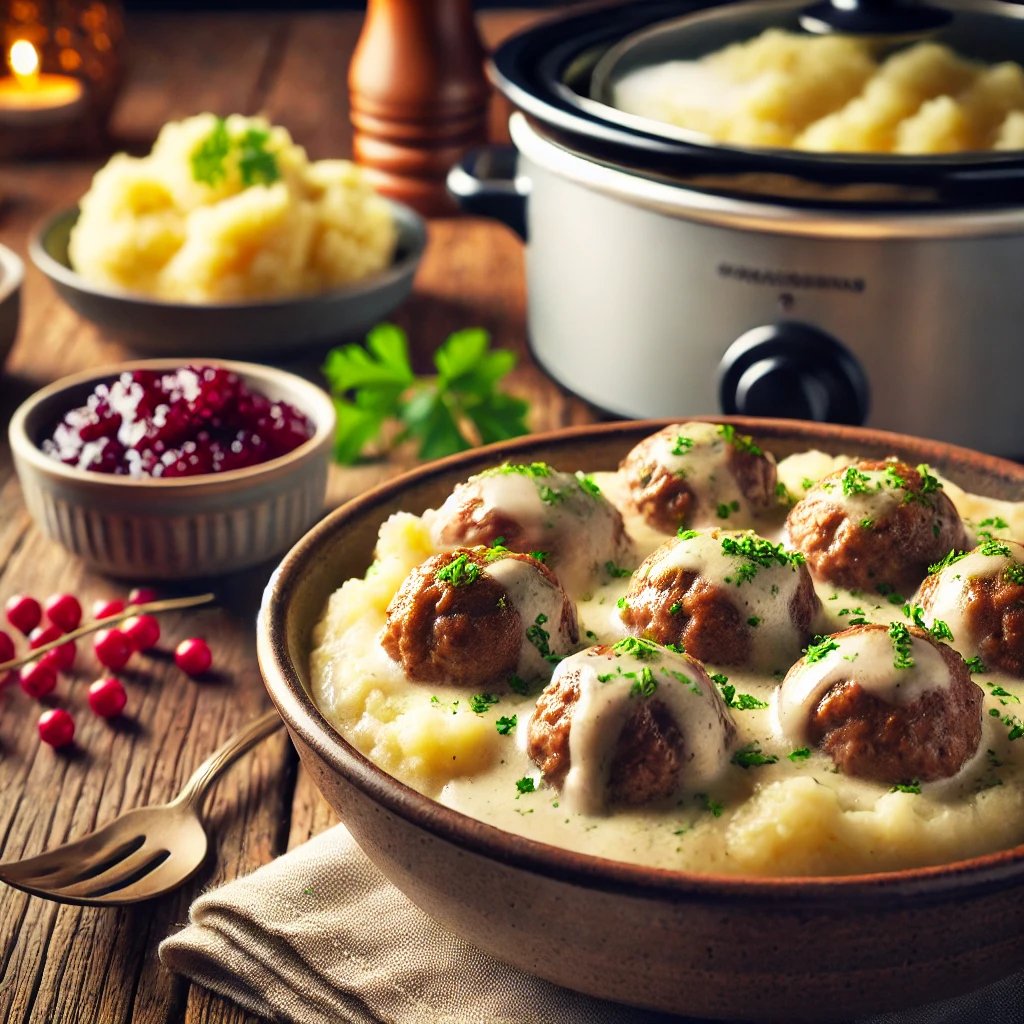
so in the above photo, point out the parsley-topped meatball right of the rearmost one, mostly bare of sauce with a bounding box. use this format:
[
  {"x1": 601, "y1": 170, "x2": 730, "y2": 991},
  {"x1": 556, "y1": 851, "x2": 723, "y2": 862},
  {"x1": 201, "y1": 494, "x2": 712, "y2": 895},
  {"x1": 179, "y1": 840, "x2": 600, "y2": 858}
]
[{"x1": 785, "y1": 460, "x2": 969, "y2": 592}]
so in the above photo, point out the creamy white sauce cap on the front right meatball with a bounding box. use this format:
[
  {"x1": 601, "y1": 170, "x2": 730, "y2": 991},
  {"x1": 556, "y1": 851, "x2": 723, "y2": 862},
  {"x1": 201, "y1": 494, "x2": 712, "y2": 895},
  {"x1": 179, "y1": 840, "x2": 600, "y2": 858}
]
[{"x1": 772, "y1": 630, "x2": 950, "y2": 746}]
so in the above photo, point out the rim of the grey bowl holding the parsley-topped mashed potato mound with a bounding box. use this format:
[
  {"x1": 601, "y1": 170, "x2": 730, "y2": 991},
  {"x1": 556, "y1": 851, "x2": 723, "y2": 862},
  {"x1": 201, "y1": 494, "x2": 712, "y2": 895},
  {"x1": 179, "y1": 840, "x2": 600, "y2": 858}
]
[{"x1": 29, "y1": 197, "x2": 427, "y2": 311}]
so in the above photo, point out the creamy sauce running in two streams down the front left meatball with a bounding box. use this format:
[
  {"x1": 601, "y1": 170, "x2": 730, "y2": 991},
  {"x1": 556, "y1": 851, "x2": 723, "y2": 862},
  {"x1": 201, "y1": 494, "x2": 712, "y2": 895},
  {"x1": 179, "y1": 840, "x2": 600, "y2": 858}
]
[{"x1": 553, "y1": 650, "x2": 735, "y2": 814}]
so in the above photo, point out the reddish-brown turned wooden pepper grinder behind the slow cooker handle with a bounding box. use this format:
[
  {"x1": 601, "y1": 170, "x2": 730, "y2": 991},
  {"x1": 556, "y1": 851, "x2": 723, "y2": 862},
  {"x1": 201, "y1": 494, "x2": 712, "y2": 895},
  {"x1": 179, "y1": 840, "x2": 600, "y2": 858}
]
[{"x1": 348, "y1": 0, "x2": 489, "y2": 216}]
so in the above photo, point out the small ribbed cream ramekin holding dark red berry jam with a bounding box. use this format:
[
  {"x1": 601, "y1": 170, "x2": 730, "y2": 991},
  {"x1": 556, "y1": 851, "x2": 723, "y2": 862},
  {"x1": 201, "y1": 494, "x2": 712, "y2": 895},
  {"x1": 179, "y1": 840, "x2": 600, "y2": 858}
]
[{"x1": 9, "y1": 359, "x2": 335, "y2": 580}]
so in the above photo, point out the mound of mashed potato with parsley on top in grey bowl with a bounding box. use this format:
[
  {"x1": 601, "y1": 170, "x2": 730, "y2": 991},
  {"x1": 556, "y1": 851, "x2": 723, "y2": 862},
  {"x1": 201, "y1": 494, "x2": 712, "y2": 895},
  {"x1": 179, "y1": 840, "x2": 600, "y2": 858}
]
[{"x1": 68, "y1": 114, "x2": 396, "y2": 302}]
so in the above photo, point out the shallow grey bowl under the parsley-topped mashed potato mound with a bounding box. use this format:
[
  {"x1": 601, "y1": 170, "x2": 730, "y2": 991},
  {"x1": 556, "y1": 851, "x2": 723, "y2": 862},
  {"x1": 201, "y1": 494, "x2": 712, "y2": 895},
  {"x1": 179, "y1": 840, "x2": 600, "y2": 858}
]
[{"x1": 29, "y1": 201, "x2": 427, "y2": 358}]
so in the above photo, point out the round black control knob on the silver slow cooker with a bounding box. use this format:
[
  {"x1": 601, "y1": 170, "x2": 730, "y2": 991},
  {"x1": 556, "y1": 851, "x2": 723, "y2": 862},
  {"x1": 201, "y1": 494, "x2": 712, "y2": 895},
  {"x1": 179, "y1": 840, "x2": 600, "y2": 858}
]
[{"x1": 719, "y1": 322, "x2": 870, "y2": 426}]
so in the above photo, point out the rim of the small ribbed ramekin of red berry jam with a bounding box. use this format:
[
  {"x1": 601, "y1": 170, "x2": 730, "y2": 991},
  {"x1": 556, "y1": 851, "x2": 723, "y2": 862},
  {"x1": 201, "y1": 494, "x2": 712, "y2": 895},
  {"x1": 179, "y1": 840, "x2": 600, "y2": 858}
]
[{"x1": 8, "y1": 356, "x2": 336, "y2": 493}]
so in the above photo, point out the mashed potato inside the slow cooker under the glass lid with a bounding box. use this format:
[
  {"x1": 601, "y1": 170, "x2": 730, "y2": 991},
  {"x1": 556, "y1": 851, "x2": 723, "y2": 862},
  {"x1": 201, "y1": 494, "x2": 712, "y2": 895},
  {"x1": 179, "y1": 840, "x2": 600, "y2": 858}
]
[{"x1": 614, "y1": 29, "x2": 1024, "y2": 154}]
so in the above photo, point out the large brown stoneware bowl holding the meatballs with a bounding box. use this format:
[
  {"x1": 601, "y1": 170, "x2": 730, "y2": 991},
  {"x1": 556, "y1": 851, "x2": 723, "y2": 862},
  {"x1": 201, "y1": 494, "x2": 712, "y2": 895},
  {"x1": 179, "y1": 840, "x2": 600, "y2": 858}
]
[{"x1": 258, "y1": 418, "x2": 1024, "y2": 1022}]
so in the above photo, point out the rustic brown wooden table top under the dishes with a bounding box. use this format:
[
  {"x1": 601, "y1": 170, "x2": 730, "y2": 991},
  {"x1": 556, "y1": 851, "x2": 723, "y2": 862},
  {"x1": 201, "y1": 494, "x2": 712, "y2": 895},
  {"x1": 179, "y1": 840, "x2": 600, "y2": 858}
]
[{"x1": 0, "y1": 12, "x2": 593, "y2": 1024}]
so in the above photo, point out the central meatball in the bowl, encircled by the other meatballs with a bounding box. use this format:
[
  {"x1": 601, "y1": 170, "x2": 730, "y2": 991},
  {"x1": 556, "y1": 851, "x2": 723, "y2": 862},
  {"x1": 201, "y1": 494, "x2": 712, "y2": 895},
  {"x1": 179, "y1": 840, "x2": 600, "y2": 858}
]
[{"x1": 621, "y1": 529, "x2": 821, "y2": 672}]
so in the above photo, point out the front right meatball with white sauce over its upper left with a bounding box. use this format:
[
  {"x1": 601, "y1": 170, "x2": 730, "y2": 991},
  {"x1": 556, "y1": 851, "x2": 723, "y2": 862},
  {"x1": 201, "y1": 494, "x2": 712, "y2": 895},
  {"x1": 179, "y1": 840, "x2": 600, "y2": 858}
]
[{"x1": 775, "y1": 623, "x2": 984, "y2": 785}]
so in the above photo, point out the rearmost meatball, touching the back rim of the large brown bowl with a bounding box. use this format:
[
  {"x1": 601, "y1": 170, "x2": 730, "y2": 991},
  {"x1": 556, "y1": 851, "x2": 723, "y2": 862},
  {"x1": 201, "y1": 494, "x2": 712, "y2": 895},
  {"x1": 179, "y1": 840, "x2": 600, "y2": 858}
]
[{"x1": 620, "y1": 423, "x2": 778, "y2": 534}]
